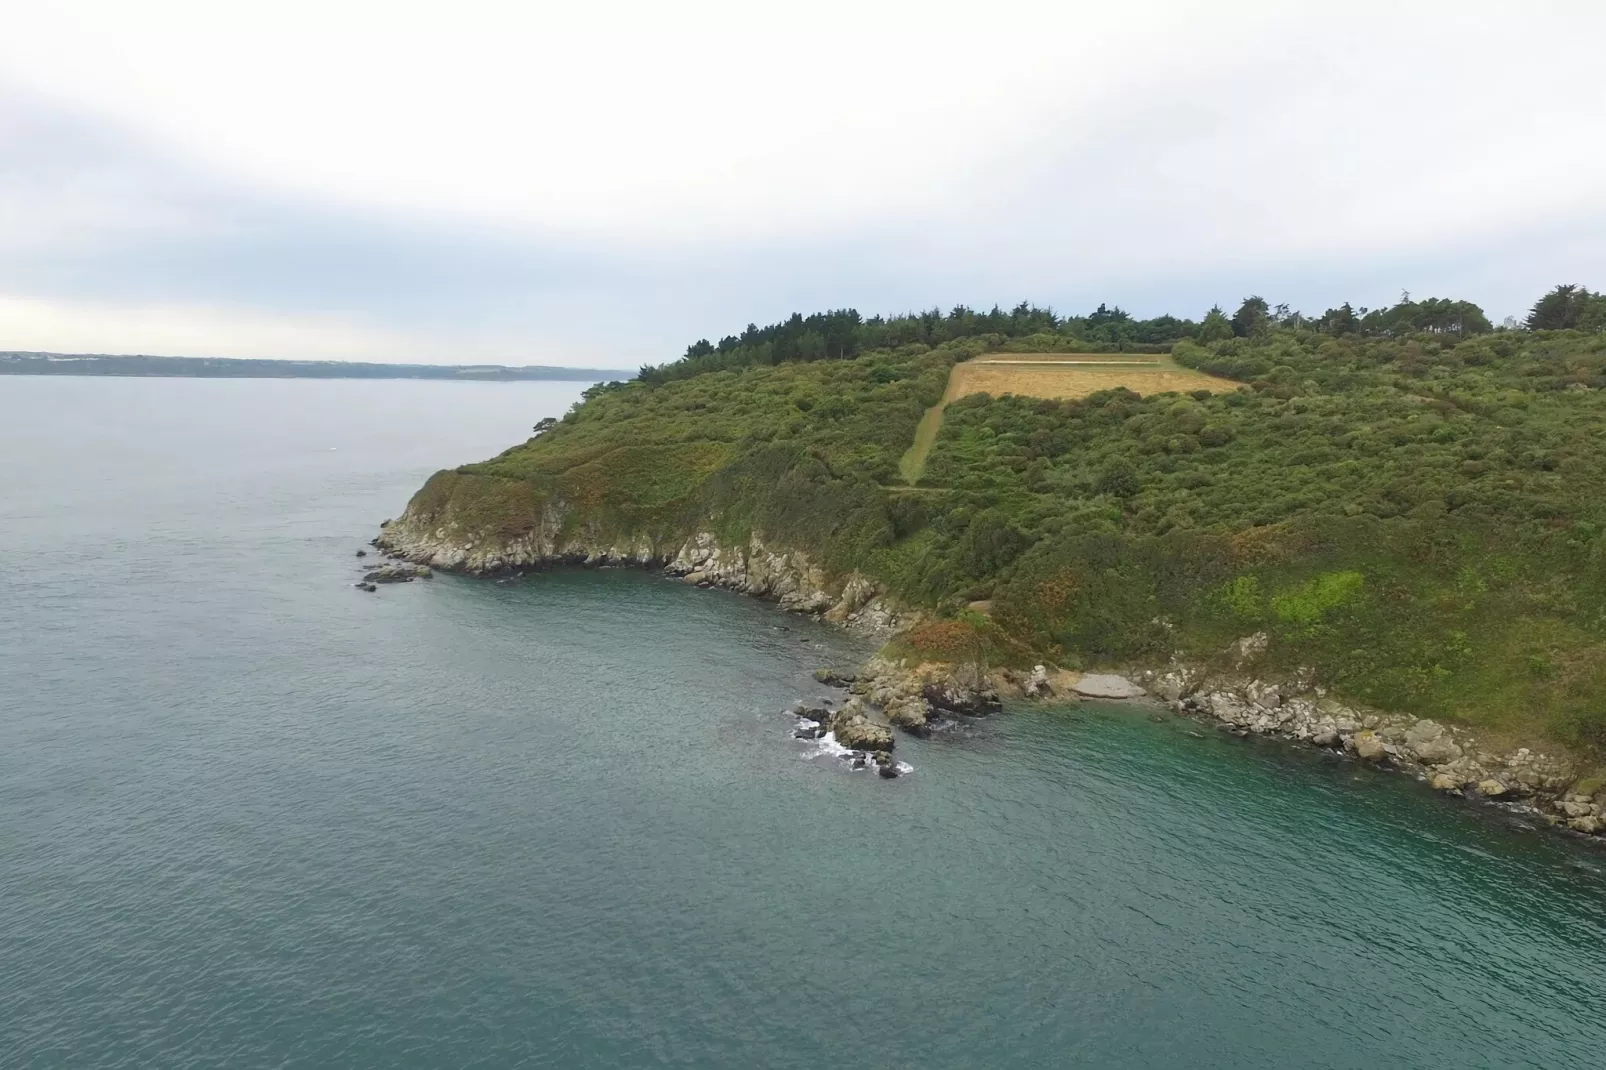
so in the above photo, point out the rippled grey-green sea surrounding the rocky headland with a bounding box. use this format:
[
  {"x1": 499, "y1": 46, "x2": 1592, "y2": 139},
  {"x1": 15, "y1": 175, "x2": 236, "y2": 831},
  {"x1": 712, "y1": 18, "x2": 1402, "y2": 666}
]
[{"x1": 0, "y1": 378, "x2": 1606, "y2": 1070}]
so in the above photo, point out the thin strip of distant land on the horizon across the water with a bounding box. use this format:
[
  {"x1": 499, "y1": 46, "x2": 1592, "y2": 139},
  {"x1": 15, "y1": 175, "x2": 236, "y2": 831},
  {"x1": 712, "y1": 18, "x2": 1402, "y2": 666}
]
[{"x1": 0, "y1": 352, "x2": 636, "y2": 382}]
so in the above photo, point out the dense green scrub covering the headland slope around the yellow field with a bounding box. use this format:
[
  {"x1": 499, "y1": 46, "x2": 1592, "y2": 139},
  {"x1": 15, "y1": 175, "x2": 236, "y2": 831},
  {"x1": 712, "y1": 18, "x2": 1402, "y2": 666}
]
[{"x1": 416, "y1": 288, "x2": 1606, "y2": 745}]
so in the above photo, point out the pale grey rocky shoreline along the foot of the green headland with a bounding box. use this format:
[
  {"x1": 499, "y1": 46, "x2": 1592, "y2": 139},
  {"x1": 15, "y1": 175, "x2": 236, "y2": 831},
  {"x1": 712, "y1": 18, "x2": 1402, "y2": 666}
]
[{"x1": 373, "y1": 506, "x2": 1606, "y2": 843}]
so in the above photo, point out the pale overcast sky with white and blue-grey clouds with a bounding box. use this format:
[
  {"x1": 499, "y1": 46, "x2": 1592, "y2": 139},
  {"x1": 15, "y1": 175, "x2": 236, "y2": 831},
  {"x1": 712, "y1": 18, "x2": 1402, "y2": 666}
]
[{"x1": 0, "y1": 0, "x2": 1606, "y2": 366}]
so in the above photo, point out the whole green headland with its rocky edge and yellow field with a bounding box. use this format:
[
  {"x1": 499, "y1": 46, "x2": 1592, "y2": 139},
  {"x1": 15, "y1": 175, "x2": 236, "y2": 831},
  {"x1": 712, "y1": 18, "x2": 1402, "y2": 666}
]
[{"x1": 369, "y1": 295, "x2": 1606, "y2": 832}]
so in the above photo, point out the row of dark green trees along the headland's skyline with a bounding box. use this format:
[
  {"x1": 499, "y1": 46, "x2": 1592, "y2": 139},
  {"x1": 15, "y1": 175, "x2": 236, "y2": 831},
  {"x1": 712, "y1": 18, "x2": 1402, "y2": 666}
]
[{"x1": 638, "y1": 284, "x2": 1606, "y2": 384}]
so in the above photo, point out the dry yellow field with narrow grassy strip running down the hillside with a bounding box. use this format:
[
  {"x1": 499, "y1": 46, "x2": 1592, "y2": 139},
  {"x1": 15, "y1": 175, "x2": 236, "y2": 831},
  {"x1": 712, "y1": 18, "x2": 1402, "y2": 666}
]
[{"x1": 898, "y1": 353, "x2": 1240, "y2": 487}]
